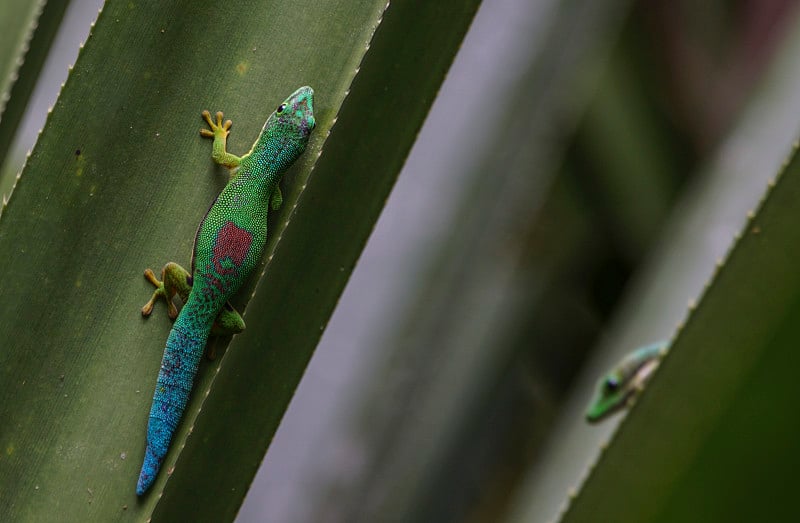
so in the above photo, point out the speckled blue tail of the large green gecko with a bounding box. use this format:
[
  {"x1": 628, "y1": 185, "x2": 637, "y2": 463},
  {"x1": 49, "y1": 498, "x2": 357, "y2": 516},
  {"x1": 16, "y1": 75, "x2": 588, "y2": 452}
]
[{"x1": 136, "y1": 320, "x2": 208, "y2": 496}]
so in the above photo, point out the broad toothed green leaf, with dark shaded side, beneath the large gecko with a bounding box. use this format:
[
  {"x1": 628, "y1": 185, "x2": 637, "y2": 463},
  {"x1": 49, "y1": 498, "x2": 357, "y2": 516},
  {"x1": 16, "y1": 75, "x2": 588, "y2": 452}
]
[{"x1": 0, "y1": 0, "x2": 477, "y2": 521}]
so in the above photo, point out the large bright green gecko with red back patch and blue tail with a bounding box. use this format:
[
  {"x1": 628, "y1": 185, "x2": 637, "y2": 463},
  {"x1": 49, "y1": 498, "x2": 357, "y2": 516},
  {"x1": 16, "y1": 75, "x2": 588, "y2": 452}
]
[{"x1": 136, "y1": 86, "x2": 315, "y2": 496}]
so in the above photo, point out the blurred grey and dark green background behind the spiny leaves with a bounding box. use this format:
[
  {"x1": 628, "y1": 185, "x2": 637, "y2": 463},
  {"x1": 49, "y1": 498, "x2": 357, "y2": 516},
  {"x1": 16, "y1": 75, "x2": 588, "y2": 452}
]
[{"x1": 3, "y1": 0, "x2": 800, "y2": 523}]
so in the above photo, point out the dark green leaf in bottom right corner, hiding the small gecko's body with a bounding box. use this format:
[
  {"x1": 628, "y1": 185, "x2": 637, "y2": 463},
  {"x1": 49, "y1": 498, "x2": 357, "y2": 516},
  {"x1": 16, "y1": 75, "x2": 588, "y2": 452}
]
[{"x1": 563, "y1": 146, "x2": 800, "y2": 522}]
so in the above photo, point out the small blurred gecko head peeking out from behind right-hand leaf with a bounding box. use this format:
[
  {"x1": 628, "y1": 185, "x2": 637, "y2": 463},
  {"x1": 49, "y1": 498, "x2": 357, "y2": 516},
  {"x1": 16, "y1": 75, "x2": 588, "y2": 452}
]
[{"x1": 586, "y1": 341, "x2": 667, "y2": 423}]
